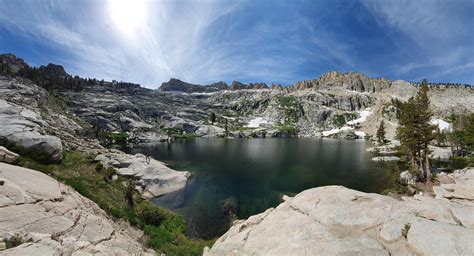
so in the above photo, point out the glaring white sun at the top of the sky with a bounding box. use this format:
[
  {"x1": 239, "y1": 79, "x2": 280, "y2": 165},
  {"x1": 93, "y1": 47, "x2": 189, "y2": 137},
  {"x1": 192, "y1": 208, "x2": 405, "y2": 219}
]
[{"x1": 108, "y1": 0, "x2": 147, "y2": 36}]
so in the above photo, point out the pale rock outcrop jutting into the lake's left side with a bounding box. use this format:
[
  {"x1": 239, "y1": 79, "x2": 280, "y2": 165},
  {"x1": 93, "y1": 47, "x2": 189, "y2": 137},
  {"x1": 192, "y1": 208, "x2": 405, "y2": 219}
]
[{"x1": 96, "y1": 150, "x2": 191, "y2": 199}]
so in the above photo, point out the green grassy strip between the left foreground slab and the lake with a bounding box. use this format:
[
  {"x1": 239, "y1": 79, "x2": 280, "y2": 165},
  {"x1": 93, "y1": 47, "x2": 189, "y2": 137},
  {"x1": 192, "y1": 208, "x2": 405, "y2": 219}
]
[{"x1": 16, "y1": 152, "x2": 214, "y2": 255}]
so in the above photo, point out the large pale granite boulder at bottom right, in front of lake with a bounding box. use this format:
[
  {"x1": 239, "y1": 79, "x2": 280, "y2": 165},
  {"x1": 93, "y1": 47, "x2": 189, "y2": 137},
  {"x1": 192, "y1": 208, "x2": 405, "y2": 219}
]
[{"x1": 205, "y1": 169, "x2": 474, "y2": 255}]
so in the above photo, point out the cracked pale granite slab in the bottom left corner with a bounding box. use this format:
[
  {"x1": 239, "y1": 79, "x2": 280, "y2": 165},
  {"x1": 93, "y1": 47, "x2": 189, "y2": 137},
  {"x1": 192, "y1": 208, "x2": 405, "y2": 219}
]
[{"x1": 0, "y1": 163, "x2": 154, "y2": 255}]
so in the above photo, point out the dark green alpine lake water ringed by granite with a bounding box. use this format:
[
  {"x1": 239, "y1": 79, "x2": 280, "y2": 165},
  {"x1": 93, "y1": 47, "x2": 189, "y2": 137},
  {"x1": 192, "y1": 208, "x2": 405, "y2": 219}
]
[{"x1": 124, "y1": 138, "x2": 394, "y2": 238}]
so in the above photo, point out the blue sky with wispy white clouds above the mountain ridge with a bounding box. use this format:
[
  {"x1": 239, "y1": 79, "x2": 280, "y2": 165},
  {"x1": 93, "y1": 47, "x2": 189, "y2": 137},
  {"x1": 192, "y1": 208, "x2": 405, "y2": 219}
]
[{"x1": 0, "y1": 0, "x2": 474, "y2": 88}]
